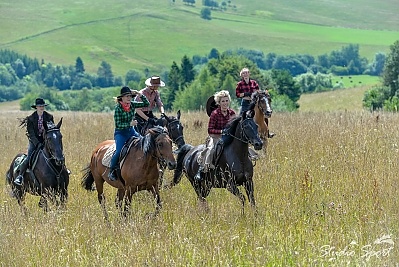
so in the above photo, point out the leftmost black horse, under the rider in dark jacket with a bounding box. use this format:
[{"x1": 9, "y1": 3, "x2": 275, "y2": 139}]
[{"x1": 6, "y1": 118, "x2": 69, "y2": 214}]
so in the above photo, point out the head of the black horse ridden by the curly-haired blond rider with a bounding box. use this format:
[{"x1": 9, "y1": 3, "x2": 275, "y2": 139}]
[{"x1": 236, "y1": 110, "x2": 263, "y2": 150}]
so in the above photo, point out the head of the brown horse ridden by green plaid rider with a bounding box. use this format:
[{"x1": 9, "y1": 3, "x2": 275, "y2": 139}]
[{"x1": 148, "y1": 126, "x2": 176, "y2": 170}]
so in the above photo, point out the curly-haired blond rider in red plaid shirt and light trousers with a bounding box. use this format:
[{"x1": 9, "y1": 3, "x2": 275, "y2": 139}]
[{"x1": 194, "y1": 90, "x2": 236, "y2": 180}]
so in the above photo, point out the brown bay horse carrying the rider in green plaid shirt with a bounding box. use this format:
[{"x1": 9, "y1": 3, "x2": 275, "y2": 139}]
[{"x1": 81, "y1": 126, "x2": 176, "y2": 221}]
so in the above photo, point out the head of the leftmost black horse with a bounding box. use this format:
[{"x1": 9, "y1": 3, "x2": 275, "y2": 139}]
[{"x1": 43, "y1": 118, "x2": 65, "y2": 166}]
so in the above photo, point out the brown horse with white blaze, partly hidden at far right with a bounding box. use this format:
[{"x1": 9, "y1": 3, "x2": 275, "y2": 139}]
[{"x1": 251, "y1": 91, "x2": 273, "y2": 149}]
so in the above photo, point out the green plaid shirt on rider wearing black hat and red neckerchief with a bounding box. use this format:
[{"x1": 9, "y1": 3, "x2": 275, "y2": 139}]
[{"x1": 114, "y1": 95, "x2": 150, "y2": 130}]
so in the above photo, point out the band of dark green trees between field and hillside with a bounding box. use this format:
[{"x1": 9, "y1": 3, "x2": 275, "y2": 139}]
[{"x1": 0, "y1": 39, "x2": 396, "y2": 111}]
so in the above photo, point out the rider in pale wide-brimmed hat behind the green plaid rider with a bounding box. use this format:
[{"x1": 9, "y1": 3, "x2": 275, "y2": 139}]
[{"x1": 135, "y1": 76, "x2": 165, "y2": 133}]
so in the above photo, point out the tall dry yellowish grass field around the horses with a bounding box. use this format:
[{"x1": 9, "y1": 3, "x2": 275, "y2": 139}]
[{"x1": 0, "y1": 111, "x2": 399, "y2": 267}]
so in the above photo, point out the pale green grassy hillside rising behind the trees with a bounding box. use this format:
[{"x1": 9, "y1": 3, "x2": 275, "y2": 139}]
[{"x1": 0, "y1": 0, "x2": 399, "y2": 75}]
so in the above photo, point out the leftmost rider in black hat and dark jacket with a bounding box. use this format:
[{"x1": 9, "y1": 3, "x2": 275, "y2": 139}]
[{"x1": 14, "y1": 98, "x2": 54, "y2": 185}]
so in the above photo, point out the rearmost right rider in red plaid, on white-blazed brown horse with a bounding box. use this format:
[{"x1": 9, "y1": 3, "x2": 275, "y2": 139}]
[{"x1": 236, "y1": 68, "x2": 276, "y2": 138}]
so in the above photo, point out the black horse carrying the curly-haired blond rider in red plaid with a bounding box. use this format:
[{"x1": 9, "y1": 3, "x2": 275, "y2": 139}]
[{"x1": 172, "y1": 110, "x2": 263, "y2": 216}]
